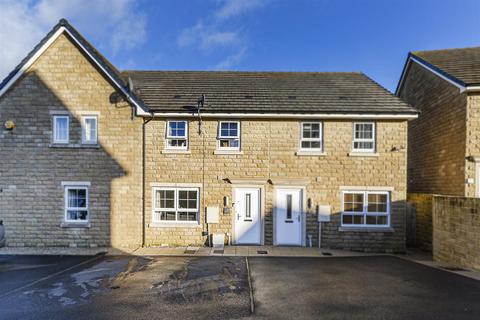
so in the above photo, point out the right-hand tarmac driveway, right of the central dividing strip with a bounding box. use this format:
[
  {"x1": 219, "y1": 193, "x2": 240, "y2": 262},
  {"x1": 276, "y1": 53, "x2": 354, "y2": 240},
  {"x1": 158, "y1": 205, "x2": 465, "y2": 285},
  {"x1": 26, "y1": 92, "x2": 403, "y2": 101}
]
[{"x1": 249, "y1": 256, "x2": 480, "y2": 320}]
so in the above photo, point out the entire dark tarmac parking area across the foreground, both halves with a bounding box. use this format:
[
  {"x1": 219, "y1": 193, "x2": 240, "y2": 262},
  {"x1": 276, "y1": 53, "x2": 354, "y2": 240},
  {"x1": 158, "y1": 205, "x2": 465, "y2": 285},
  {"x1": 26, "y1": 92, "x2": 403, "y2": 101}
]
[{"x1": 0, "y1": 256, "x2": 480, "y2": 320}]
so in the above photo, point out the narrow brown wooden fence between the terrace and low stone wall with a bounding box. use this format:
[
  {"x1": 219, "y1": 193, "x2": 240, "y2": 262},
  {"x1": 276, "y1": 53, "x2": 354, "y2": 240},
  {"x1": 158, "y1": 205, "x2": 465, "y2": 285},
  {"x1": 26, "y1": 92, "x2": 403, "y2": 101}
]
[{"x1": 407, "y1": 193, "x2": 433, "y2": 251}]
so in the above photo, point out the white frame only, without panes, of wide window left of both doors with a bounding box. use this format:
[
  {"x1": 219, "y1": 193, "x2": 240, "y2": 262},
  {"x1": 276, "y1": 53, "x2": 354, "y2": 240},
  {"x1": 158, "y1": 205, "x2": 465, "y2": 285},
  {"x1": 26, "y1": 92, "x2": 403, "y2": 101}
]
[{"x1": 152, "y1": 187, "x2": 200, "y2": 225}]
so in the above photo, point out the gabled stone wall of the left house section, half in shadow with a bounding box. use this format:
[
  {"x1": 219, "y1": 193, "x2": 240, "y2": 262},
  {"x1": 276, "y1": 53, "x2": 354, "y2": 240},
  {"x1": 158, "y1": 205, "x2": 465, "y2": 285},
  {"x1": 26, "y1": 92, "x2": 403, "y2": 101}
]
[{"x1": 0, "y1": 35, "x2": 142, "y2": 247}]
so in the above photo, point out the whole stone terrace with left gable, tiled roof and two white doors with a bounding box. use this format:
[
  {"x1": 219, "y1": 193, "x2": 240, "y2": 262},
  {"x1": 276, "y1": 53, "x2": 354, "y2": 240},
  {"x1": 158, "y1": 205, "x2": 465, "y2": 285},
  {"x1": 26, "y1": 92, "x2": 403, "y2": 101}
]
[{"x1": 0, "y1": 20, "x2": 417, "y2": 252}]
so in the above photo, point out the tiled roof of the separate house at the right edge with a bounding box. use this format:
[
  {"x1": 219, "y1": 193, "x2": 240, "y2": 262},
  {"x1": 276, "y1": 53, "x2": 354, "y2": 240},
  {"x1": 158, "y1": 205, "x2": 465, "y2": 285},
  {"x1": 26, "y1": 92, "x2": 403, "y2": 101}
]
[{"x1": 412, "y1": 47, "x2": 480, "y2": 86}]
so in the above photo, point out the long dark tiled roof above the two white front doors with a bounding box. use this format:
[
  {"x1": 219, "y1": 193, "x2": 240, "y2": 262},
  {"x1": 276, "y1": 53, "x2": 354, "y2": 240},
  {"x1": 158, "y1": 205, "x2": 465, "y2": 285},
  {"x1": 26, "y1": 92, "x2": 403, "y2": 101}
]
[{"x1": 122, "y1": 71, "x2": 417, "y2": 114}]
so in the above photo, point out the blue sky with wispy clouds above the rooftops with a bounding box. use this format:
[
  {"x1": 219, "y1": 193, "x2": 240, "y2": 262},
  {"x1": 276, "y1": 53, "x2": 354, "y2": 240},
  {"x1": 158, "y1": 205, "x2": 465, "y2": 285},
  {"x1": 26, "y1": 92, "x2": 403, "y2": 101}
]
[{"x1": 0, "y1": 0, "x2": 480, "y2": 91}]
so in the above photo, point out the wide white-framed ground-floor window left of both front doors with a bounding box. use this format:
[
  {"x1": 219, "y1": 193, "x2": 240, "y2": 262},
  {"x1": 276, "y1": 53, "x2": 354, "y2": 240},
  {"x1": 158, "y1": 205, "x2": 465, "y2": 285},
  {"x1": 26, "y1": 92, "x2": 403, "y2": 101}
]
[{"x1": 152, "y1": 187, "x2": 200, "y2": 223}]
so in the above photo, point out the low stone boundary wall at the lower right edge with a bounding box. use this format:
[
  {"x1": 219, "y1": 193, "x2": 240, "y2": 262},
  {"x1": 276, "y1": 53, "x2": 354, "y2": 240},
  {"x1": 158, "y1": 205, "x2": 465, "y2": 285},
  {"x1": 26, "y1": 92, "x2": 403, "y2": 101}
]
[{"x1": 433, "y1": 196, "x2": 480, "y2": 270}]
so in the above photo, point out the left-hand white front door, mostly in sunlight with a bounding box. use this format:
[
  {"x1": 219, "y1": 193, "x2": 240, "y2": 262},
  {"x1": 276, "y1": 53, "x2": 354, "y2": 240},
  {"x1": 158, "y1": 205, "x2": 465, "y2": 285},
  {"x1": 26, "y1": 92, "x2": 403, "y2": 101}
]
[{"x1": 234, "y1": 188, "x2": 262, "y2": 244}]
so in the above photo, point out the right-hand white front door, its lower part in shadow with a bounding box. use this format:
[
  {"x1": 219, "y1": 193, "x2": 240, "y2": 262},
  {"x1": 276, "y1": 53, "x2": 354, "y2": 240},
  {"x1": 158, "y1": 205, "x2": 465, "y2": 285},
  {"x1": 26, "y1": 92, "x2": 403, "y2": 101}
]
[{"x1": 275, "y1": 188, "x2": 303, "y2": 246}]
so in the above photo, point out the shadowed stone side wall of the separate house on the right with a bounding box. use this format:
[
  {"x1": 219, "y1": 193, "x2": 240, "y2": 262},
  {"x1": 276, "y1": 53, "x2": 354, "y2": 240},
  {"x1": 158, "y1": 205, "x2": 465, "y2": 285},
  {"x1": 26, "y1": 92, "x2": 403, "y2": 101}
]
[{"x1": 400, "y1": 63, "x2": 467, "y2": 196}]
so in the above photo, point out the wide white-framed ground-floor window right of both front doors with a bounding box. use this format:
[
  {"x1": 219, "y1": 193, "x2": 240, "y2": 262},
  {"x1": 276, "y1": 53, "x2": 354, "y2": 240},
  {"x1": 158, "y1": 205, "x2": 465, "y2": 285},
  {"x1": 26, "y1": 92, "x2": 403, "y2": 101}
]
[{"x1": 342, "y1": 191, "x2": 390, "y2": 227}]
